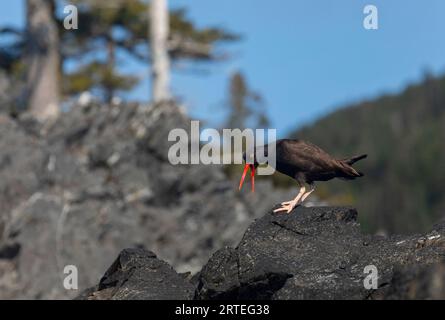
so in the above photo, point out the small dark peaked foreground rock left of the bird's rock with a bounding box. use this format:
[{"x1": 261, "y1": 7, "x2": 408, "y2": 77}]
[{"x1": 81, "y1": 249, "x2": 194, "y2": 300}]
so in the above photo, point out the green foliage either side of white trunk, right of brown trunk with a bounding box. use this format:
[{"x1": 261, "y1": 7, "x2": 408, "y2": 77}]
[{"x1": 60, "y1": 0, "x2": 237, "y2": 100}]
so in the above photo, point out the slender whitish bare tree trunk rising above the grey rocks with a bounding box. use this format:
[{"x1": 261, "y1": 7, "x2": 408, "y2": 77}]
[{"x1": 149, "y1": 0, "x2": 170, "y2": 102}]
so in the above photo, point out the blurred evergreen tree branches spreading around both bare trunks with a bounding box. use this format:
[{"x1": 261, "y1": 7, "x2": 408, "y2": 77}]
[{"x1": 0, "y1": 0, "x2": 239, "y2": 105}]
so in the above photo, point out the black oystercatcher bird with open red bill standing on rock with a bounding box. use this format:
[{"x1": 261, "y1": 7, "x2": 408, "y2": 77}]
[{"x1": 239, "y1": 139, "x2": 367, "y2": 213}]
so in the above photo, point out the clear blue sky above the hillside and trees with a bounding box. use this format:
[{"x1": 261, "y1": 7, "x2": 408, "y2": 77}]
[{"x1": 0, "y1": 0, "x2": 445, "y2": 137}]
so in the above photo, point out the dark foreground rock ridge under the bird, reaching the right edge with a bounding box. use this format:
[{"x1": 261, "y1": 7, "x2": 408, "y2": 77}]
[{"x1": 81, "y1": 207, "x2": 445, "y2": 300}]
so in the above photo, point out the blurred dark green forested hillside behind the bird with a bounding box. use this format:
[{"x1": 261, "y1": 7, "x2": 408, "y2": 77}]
[{"x1": 292, "y1": 75, "x2": 445, "y2": 233}]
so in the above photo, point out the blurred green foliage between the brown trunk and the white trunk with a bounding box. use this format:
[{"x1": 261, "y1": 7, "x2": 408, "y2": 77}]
[{"x1": 59, "y1": 0, "x2": 147, "y2": 102}]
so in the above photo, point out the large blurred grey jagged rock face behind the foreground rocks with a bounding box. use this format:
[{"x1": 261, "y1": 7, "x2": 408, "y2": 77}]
[{"x1": 0, "y1": 104, "x2": 294, "y2": 299}]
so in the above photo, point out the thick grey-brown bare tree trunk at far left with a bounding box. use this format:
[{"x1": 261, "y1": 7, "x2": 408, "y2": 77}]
[{"x1": 26, "y1": 0, "x2": 60, "y2": 121}]
